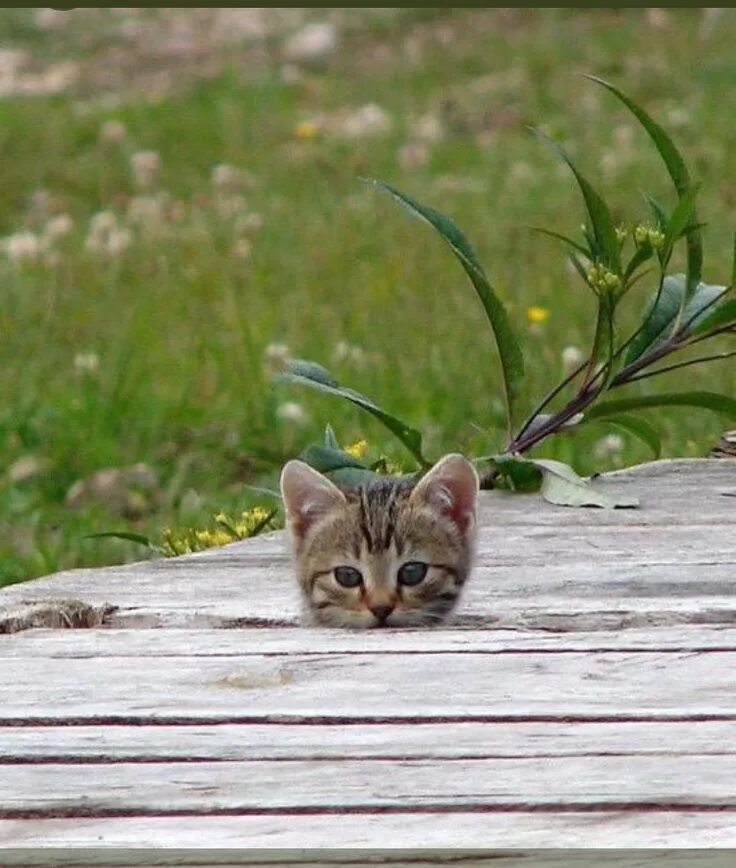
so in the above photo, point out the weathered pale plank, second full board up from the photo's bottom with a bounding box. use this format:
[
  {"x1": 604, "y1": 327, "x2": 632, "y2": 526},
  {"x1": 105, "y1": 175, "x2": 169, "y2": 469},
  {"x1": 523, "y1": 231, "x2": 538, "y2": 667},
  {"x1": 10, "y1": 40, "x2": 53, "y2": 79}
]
[{"x1": 0, "y1": 754, "x2": 736, "y2": 819}]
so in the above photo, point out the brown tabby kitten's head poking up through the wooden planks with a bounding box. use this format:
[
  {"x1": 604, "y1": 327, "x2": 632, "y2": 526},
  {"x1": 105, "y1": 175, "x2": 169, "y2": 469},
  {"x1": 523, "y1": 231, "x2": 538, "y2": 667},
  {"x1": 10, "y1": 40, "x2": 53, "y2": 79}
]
[{"x1": 281, "y1": 455, "x2": 478, "y2": 628}]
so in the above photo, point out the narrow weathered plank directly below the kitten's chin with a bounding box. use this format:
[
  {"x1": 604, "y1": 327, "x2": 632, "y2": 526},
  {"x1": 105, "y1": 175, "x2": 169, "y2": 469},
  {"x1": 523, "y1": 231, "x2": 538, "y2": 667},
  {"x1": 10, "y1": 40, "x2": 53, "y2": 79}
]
[{"x1": 7, "y1": 624, "x2": 736, "y2": 661}]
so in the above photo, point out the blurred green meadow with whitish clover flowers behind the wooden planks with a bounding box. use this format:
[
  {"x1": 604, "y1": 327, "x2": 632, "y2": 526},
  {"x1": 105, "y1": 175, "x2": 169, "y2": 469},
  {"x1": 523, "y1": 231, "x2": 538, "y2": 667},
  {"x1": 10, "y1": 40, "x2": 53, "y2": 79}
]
[{"x1": 0, "y1": 9, "x2": 736, "y2": 584}]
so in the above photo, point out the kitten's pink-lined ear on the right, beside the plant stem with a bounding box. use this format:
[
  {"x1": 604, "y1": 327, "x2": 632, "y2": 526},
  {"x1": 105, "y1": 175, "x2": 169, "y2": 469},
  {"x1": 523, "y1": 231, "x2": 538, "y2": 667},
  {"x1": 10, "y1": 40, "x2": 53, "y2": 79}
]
[{"x1": 411, "y1": 453, "x2": 480, "y2": 534}]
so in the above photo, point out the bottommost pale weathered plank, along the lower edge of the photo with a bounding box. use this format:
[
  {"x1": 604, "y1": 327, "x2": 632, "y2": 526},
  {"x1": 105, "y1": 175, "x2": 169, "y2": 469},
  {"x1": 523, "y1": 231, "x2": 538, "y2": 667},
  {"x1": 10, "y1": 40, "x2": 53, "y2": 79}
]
[{"x1": 0, "y1": 811, "x2": 736, "y2": 852}]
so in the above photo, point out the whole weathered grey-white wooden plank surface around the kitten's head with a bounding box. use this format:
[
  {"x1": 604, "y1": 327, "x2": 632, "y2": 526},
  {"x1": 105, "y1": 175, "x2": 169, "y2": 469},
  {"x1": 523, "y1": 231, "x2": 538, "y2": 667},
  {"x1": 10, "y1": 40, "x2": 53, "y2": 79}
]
[{"x1": 0, "y1": 460, "x2": 736, "y2": 848}]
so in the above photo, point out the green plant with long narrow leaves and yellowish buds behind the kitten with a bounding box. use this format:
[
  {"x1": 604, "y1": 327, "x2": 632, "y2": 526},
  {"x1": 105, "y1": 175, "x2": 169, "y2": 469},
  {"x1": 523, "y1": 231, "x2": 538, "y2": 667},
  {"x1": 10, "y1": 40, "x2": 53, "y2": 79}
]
[{"x1": 278, "y1": 76, "x2": 736, "y2": 506}]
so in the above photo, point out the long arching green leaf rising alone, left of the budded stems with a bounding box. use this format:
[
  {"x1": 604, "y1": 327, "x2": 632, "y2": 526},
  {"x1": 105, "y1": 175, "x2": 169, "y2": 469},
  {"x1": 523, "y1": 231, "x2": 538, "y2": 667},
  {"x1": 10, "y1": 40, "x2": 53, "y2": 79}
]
[{"x1": 371, "y1": 181, "x2": 524, "y2": 434}]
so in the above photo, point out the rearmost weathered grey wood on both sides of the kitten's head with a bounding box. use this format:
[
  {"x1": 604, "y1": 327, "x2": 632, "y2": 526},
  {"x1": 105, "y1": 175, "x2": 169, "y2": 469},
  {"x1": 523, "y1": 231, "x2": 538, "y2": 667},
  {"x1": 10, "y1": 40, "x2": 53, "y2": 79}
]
[{"x1": 0, "y1": 460, "x2": 736, "y2": 630}]
